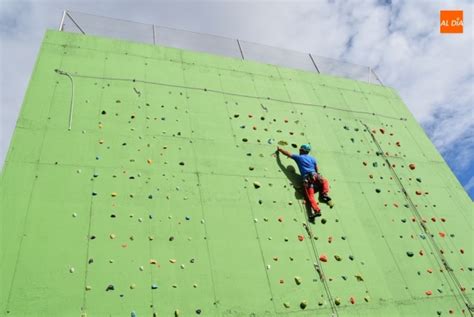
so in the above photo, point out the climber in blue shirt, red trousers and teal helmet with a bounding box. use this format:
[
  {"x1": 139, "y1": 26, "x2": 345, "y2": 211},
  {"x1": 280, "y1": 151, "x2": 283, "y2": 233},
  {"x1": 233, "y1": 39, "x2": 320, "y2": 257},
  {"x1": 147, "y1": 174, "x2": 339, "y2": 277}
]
[{"x1": 276, "y1": 144, "x2": 334, "y2": 220}]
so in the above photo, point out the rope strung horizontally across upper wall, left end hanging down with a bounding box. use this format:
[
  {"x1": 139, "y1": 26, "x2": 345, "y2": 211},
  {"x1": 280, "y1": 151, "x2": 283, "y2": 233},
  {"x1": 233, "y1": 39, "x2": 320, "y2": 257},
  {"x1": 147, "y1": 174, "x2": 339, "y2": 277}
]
[{"x1": 54, "y1": 69, "x2": 407, "y2": 130}]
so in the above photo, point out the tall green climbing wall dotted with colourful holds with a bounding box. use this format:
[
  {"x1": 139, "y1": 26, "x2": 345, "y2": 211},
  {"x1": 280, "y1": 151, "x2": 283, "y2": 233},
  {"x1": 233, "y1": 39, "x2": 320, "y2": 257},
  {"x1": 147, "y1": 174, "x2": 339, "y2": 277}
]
[{"x1": 0, "y1": 31, "x2": 474, "y2": 317}]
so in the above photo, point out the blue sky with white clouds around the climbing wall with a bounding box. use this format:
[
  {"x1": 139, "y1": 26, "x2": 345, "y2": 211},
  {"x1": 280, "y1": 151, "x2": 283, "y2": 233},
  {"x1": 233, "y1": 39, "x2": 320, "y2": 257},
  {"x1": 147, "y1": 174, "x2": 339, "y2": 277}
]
[{"x1": 0, "y1": 0, "x2": 474, "y2": 199}]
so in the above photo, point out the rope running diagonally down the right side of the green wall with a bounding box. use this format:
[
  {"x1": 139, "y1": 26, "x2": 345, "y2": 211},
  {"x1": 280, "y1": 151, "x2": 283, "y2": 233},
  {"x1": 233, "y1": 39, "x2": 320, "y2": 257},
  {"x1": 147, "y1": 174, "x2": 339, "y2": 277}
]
[{"x1": 359, "y1": 120, "x2": 474, "y2": 316}]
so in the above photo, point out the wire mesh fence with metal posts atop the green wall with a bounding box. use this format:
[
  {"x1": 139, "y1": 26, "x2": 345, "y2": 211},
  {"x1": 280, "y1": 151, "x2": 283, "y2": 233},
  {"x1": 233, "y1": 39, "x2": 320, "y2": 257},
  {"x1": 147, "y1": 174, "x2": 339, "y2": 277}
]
[{"x1": 59, "y1": 11, "x2": 383, "y2": 85}]
